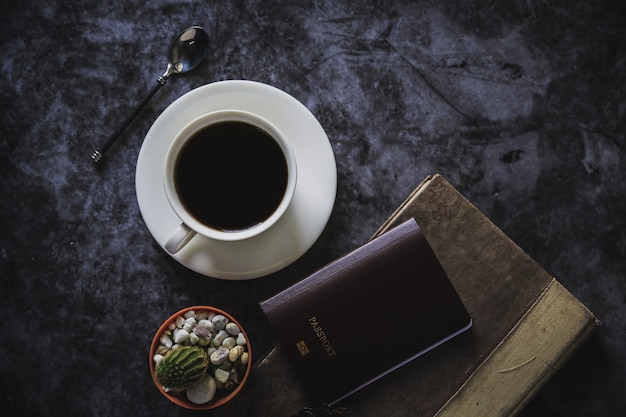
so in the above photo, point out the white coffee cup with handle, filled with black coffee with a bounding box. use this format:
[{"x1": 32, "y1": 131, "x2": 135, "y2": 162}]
[{"x1": 163, "y1": 110, "x2": 297, "y2": 254}]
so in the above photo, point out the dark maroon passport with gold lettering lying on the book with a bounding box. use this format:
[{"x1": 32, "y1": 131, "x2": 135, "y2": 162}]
[{"x1": 260, "y1": 219, "x2": 472, "y2": 405}]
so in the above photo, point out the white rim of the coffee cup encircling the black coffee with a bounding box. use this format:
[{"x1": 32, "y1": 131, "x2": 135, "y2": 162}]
[{"x1": 163, "y1": 109, "x2": 297, "y2": 241}]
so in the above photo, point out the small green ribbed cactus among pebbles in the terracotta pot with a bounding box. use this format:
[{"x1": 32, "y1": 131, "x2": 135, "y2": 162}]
[{"x1": 156, "y1": 346, "x2": 209, "y2": 391}]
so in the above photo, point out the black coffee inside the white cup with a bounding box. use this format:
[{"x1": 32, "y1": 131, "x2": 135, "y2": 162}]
[{"x1": 174, "y1": 121, "x2": 287, "y2": 231}]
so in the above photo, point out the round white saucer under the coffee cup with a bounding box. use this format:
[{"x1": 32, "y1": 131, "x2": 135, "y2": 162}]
[{"x1": 135, "y1": 80, "x2": 337, "y2": 280}]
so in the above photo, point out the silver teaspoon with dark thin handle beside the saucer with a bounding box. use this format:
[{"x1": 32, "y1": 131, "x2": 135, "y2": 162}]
[{"x1": 91, "y1": 26, "x2": 209, "y2": 162}]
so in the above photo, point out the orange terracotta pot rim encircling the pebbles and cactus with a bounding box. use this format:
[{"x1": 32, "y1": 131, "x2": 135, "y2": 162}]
[{"x1": 149, "y1": 306, "x2": 252, "y2": 410}]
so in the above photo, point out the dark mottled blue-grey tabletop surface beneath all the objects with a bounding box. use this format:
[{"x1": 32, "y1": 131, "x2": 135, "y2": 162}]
[{"x1": 0, "y1": 0, "x2": 626, "y2": 416}]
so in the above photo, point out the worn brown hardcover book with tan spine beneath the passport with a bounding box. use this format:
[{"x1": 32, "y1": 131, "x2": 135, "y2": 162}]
[{"x1": 219, "y1": 175, "x2": 599, "y2": 417}]
